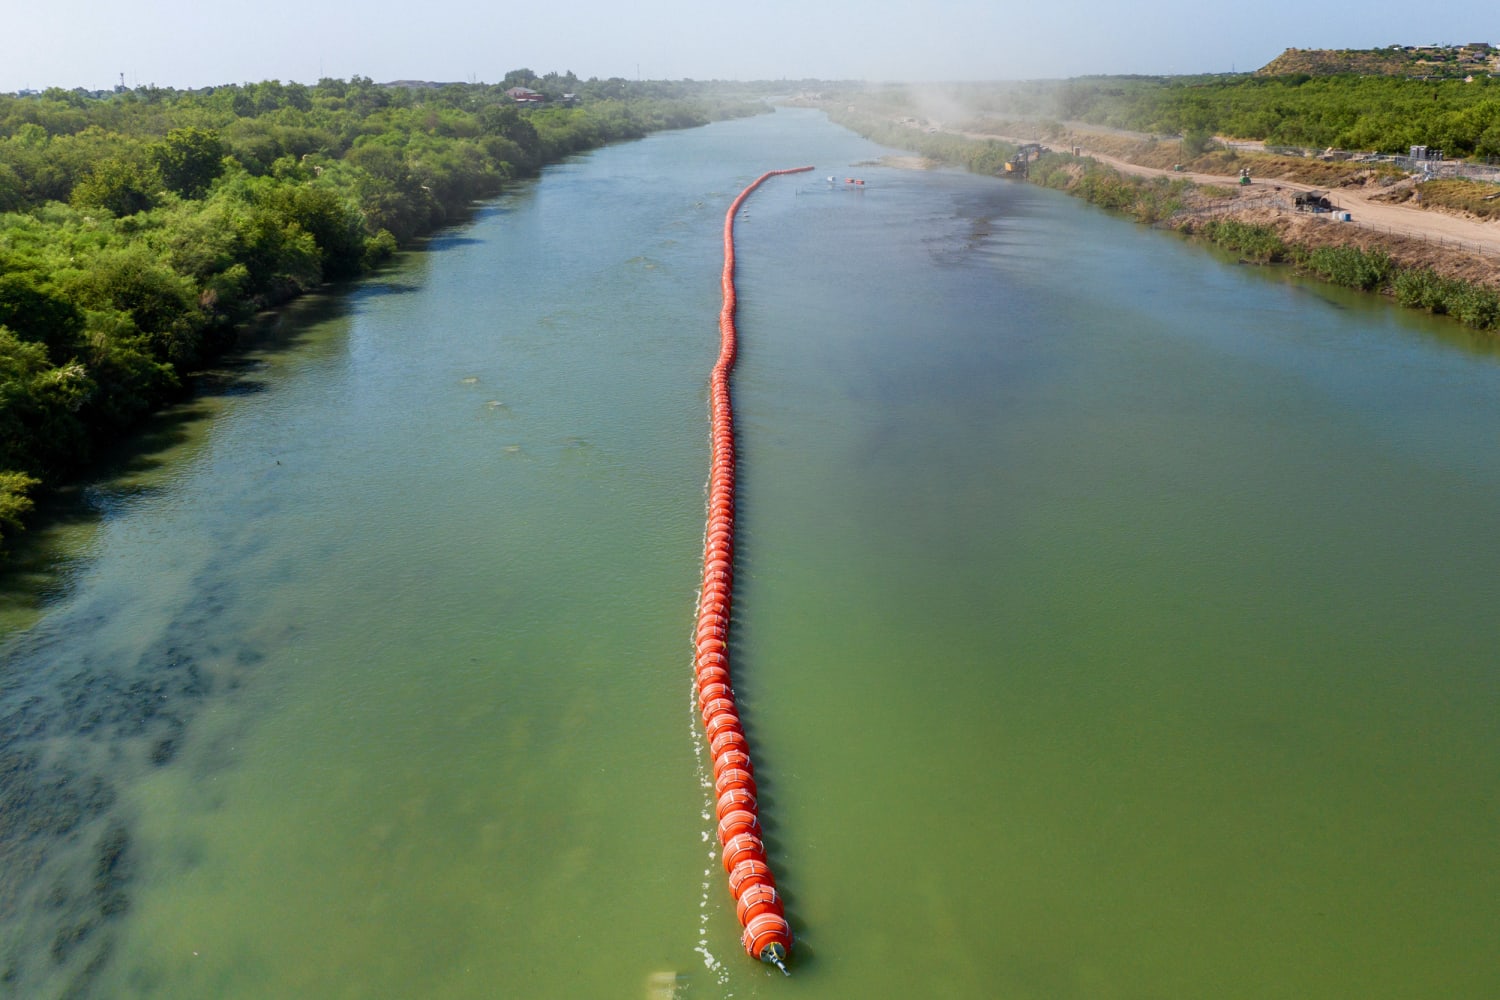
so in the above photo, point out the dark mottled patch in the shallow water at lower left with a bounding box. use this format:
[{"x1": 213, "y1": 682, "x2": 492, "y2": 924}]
[{"x1": 0, "y1": 521, "x2": 279, "y2": 997}]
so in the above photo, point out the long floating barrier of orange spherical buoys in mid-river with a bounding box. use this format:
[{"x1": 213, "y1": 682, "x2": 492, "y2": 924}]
[{"x1": 693, "y1": 166, "x2": 813, "y2": 975}]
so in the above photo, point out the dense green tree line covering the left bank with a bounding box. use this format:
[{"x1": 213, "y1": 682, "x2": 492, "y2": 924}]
[{"x1": 0, "y1": 76, "x2": 761, "y2": 548}]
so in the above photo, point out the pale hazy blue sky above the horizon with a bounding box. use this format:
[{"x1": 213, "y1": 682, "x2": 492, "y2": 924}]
[{"x1": 0, "y1": 0, "x2": 1500, "y2": 91}]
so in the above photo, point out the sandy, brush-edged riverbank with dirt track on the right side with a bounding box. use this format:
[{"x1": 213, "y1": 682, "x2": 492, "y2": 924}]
[{"x1": 825, "y1": 105, "x2": 1500, "y2": 334}]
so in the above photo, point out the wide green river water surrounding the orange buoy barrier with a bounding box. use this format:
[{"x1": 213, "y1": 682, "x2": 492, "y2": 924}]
[{"x1": 0, "y1": 111, "x2": 1500, "y2": 1000}]
